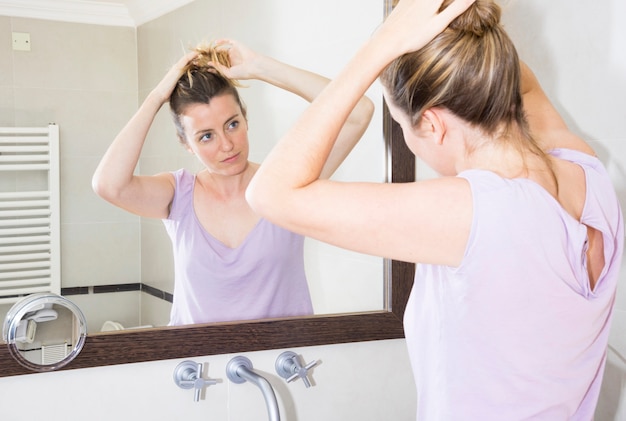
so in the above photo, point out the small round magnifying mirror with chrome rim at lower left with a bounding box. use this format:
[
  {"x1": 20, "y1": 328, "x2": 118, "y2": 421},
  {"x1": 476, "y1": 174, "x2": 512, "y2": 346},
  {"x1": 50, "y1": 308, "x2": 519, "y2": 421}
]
[{"x1": 2, "y1": 293, "x2": 87, "y2": 372}]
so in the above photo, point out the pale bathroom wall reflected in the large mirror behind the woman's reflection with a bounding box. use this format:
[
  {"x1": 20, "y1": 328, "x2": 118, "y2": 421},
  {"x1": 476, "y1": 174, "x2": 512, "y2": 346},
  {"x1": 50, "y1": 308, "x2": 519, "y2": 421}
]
[{"x1": 0, "y1": 0, "x2": 385, "y2": 333}]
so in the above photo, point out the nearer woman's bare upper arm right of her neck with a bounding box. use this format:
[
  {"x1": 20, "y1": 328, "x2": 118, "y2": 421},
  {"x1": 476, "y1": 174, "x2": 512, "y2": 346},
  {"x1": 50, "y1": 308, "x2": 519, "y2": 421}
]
[{"x1": 521, "y1": 62, "x2": 595, "y2": 155}]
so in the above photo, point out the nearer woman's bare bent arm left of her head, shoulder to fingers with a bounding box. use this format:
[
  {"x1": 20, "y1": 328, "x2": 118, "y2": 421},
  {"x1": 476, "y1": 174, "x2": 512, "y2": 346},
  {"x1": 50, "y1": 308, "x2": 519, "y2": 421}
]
[{"x1": 247, "y1": 0, "x2": 473, "y2": 264}]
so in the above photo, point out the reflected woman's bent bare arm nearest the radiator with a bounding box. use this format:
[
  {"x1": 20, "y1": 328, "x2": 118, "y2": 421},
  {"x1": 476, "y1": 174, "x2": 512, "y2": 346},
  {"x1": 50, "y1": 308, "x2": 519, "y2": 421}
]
[{"x1": 92, "y1": 53, "x2": 195, "y2": 218}]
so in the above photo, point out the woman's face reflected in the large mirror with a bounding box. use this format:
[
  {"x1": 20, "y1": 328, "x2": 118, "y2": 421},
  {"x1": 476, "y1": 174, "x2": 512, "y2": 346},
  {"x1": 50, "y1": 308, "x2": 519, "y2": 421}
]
[{"x1": 180, "y1": 94, "x2": 249, "y2": 175}]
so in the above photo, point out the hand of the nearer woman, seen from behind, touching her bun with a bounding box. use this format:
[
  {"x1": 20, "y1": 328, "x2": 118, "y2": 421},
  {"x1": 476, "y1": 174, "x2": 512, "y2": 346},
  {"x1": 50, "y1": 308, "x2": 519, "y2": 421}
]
[{"x1": 374, "y1": 0, "x2": 476, "y2": 56}]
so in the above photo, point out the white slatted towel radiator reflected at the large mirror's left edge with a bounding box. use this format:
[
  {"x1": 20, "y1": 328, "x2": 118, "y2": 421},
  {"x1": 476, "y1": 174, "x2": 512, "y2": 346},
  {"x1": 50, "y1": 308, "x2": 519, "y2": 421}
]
[{"x1": 0, "y1": 124, "x2": 61, "y2": 304}]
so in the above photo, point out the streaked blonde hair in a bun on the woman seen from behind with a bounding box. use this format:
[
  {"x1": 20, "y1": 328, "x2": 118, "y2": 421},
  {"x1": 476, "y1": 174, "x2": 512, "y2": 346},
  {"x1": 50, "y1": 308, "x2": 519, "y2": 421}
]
[{"x1": 380, "y1": 0, "x2": 556, "y2": 181}]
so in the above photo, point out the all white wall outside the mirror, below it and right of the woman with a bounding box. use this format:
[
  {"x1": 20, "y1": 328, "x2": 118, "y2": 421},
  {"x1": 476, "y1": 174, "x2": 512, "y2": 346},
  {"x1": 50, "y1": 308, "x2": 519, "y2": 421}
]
[{"x1": 0, "y1": 0, "x2": 626, "y2": 421}]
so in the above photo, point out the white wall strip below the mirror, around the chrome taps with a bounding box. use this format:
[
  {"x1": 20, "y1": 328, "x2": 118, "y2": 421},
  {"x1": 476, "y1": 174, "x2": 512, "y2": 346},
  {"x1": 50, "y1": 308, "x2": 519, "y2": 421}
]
[{"x1": 0, "y1": 340, "x2": 415, "y2": 421}]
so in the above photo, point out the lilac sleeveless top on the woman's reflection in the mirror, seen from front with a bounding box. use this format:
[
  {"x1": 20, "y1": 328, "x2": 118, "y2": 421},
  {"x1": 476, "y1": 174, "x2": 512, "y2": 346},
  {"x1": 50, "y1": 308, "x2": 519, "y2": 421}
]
[{"x1": 163, "y1": 169, "x2": 313, "y2": 325}]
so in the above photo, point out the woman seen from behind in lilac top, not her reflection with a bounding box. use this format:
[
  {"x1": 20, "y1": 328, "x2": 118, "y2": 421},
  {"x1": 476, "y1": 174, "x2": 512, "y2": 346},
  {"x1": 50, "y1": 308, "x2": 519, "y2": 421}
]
[{"x1": 247, "y1": 0, "x2": 624, "y2": 420}]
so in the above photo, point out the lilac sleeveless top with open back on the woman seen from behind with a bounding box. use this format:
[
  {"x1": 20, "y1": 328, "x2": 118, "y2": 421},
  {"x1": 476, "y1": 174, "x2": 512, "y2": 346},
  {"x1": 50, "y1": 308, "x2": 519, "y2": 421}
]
[{"x1": 404, "y1": 149, "x2": 624, "y2": 421}]
